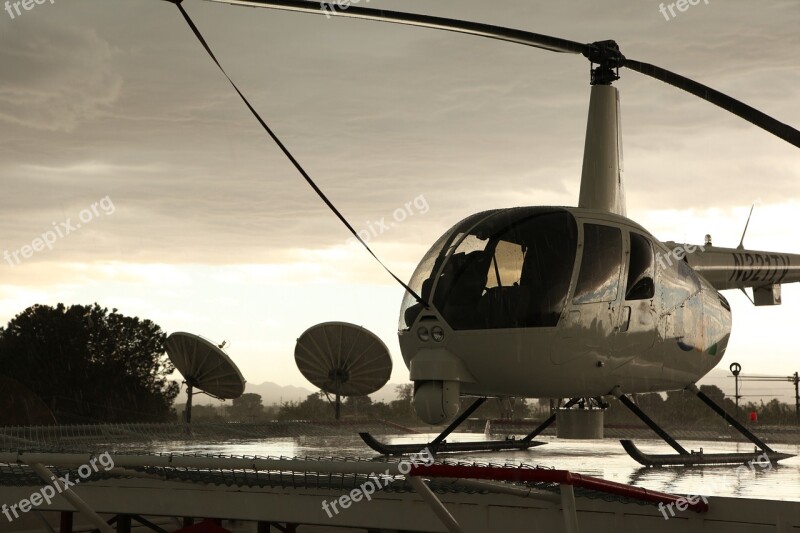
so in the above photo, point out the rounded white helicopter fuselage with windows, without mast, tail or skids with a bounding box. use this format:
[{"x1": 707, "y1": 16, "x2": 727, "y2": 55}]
[{"x1": 399, "y1": 207, "x2": 731, "y2": 397}]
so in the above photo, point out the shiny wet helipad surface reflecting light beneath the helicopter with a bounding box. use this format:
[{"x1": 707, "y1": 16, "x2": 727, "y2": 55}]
[{"x1": 150, "y1": 433, "x2": 800, "y2": 501}]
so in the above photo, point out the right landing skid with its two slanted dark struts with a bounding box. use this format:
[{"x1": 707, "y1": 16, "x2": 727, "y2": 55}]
[{"x1": 614, "y1": 385, "x2": 794, "y2": 466}]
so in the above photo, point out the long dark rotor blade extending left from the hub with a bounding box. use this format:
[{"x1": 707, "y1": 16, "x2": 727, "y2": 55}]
[{"x1": 200, "y1": 0, "x2": 591, "y2": 54}]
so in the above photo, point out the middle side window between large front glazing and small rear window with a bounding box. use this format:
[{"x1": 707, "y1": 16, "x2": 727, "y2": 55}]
[{"x1": 572, "y1": 224, "x2": 622, "y2": 304}]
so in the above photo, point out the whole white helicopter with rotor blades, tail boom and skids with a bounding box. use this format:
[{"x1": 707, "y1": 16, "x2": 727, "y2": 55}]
[{"x1": 167, "y1": 0, "x2": 800, "y2": 465}]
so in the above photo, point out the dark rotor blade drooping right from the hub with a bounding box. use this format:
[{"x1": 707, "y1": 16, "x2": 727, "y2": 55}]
[{"x1": 624, "y1": 58, "x2": 800, "y2": 148}]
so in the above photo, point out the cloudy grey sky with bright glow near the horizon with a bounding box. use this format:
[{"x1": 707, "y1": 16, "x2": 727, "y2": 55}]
[{"x1": 0, "y1": 0, "x2": 800, "y2": 394}]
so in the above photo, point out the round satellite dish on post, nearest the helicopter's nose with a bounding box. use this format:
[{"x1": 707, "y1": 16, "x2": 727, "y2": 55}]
[{"x1": 294, "y1": 322, "x2": 392, "y2": 420}]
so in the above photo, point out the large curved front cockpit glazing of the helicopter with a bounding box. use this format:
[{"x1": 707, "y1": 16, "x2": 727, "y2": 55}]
[{"x1": 400, "y1": 207, "x2": 578, "y2": 330}]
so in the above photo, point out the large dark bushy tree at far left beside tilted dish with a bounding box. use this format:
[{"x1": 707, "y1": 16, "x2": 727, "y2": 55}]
[{"x1": 0, "y1": 304, "x2": 179, "y2": 423}]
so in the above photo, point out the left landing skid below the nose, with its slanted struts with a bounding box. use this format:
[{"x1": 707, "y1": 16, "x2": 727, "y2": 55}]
[{"x1": 358, "y1": 398, "x2": 580, "y2": 455}]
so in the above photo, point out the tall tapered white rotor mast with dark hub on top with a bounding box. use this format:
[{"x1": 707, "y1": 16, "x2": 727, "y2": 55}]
[{"x1": 578, "y1": 41, "x2": 626, "y2": 216}]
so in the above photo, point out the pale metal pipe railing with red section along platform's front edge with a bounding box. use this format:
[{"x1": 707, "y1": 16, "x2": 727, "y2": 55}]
[{"x1": 0, "y1": 451, "x2": 708, "y2": 533}]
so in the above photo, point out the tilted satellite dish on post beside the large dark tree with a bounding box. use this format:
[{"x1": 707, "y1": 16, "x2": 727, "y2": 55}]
[{"x1": 166, "y1": 331, "x2": 245, "y2": 422}]
